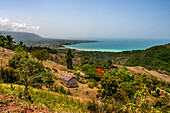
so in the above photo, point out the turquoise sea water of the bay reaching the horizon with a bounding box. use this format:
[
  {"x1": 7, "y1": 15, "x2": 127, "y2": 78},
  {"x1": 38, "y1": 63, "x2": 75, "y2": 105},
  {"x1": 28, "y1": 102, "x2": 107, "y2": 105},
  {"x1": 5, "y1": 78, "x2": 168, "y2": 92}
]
[{"x1": 65, "y1": 39, "x2": 170, "y2": 52}]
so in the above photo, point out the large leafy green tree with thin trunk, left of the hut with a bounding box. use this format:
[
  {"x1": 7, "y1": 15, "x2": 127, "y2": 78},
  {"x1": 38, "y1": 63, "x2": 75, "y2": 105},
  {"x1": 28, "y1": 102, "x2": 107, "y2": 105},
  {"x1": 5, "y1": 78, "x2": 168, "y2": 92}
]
[{"x1": 8, "y1": 48, "x2": 52, "y2": 96}]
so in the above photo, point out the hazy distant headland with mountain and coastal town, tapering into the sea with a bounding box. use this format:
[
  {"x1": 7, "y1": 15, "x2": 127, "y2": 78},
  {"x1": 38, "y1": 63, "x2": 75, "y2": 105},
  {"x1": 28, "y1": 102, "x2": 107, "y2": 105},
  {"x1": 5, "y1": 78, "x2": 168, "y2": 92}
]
[{"x1": 0, "y1": 31, "x2": 96, "y2": 49}]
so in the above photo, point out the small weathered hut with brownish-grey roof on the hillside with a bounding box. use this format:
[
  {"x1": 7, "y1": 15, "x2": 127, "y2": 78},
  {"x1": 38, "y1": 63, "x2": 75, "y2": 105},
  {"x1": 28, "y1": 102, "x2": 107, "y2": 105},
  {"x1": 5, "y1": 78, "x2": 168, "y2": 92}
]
[{"x1": 60, "y1": 73, "x2": 78, "y2": 88}]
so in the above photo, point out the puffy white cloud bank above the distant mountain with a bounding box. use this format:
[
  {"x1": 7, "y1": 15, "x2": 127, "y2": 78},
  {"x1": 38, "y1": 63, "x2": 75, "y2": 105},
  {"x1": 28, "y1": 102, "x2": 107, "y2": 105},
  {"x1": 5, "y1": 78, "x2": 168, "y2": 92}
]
[{"x1": 0, "y1": 17, "x2": 40, "y2": 32}]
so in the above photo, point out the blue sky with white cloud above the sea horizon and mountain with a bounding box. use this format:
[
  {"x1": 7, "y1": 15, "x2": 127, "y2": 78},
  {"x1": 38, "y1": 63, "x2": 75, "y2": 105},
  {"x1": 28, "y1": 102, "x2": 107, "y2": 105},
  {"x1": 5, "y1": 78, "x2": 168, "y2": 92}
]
[{"x1": 0, "y1": 0, "x2": 170, "y2": 39}]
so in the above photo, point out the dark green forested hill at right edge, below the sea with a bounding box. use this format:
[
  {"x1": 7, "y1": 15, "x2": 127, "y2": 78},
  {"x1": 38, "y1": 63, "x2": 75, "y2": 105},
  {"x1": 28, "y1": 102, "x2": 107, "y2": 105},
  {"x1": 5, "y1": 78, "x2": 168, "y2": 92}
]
[{"x1": 124, "y1": 43, "x2": 170, "y2": 75}]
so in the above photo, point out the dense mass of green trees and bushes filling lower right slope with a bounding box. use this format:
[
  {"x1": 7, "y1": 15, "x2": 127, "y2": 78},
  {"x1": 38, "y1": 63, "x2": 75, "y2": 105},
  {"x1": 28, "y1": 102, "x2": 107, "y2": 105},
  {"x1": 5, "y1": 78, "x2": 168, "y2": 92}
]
[{"x1": 77, "y1": 57, "x2": 170, "y2": 113}]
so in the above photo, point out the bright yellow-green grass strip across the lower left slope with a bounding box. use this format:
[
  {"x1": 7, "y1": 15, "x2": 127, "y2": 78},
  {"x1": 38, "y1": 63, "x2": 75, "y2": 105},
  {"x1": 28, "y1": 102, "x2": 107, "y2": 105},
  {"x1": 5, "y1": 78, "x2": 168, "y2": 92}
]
[{"x1": 0, "y1": 84, "x2": 87, "y2": 112}]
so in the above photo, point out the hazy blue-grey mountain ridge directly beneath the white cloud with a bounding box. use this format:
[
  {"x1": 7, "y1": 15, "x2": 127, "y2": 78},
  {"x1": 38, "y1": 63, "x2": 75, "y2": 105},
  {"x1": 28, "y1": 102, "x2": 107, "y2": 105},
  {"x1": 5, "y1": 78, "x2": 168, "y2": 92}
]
[{"x1": 0, "y1": 31, "x2": 43, "y2": 41}]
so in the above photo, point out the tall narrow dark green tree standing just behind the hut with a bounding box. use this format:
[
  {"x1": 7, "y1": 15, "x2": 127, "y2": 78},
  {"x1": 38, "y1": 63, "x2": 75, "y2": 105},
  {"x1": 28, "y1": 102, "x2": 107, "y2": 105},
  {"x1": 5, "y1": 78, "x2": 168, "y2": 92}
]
[{"x1": 65, "y1": 49, "x2": 74, "y2": 69}]
